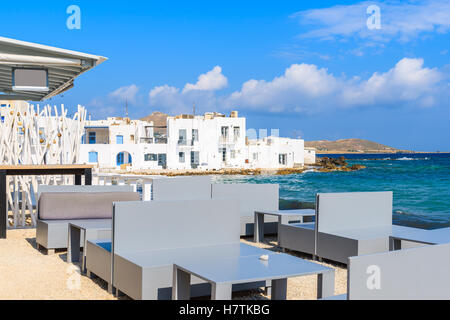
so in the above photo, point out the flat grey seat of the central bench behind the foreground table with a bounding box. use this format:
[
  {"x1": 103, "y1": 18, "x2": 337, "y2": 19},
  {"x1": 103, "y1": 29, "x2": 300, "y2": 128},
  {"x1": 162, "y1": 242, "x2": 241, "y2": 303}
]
[{"x1": 115, "y1": 243, "x2": 275, "y2": 268}]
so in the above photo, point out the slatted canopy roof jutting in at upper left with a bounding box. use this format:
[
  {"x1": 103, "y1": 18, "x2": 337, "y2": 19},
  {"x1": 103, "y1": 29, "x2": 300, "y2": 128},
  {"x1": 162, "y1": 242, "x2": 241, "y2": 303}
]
[{"x1": 0, "y1": 37, "x2": 107, "y2": 101}]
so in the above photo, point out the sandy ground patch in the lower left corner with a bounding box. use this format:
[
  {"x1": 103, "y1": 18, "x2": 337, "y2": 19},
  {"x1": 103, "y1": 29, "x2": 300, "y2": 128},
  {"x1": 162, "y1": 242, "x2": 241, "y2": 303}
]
[{"x1": 0, "y1": 229, "x2": 114, "y2": 300}]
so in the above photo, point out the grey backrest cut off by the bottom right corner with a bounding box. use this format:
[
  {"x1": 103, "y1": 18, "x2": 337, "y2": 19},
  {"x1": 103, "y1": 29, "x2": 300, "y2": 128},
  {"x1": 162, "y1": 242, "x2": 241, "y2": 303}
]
[{"x1": 348, "y1": 243, "x2": 450, "y2": 300}]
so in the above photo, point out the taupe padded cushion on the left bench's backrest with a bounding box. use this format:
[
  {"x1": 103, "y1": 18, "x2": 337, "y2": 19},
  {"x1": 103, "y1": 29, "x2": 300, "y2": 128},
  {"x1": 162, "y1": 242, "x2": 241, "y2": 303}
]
[{"x1": 39, "y1": 192, "x2": 140, "y2": 220}]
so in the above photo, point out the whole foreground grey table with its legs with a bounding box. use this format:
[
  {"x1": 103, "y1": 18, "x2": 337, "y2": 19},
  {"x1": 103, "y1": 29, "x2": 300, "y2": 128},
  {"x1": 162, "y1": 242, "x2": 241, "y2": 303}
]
[{"x1": 172, "y1": 253, "x2": 334, "y2": 300}]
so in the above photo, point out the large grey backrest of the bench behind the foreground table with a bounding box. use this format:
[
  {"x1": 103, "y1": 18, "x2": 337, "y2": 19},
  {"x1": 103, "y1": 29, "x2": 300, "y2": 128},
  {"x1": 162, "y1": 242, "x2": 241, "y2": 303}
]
[{"x1": 113, "y1": 199, "x2": 240, "y2": 253}]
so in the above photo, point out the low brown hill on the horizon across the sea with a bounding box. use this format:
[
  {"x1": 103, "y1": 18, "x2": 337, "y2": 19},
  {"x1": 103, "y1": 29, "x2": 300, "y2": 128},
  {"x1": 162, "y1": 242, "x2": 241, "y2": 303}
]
[{"x1": 305, "y1": 139, "x2": 411, "y2": 153}]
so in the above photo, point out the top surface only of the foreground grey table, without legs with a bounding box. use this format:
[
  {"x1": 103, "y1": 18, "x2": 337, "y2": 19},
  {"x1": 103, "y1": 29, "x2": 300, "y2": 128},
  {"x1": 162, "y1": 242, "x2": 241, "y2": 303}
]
[{"x1": 175, "y1": 253, "x2": 333, "y2": 284}]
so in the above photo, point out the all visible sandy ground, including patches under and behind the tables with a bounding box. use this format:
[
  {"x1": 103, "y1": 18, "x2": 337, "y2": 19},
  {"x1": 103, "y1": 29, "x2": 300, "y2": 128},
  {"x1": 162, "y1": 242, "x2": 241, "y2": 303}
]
[{"x1": 0, "y1": 229, "x2": 347, "y2": 300}]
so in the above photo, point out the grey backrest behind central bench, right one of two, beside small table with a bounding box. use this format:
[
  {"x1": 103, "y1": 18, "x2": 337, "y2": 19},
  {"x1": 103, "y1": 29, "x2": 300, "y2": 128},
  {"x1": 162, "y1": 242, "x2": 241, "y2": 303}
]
[{"x1": 212, "y1": 184, "x2": 280, "y2": 217}]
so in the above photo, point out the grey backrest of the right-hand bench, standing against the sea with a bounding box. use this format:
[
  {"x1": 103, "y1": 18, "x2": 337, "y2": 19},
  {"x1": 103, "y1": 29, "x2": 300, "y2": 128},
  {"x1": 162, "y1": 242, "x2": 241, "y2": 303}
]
[{"x1": 316, "y1": 191, "x2": 393, "y2": 233}]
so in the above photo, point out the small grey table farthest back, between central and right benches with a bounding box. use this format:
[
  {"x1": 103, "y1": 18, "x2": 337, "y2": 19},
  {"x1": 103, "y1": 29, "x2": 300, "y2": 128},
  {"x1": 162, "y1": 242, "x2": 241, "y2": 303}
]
[{"x1": 253, "y1": 209, "x2": 316, "y2": 242}]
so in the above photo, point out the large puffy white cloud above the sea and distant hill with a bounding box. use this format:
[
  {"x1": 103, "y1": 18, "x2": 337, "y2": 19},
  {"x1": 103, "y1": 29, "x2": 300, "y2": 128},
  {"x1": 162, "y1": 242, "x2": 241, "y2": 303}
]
[{"x1": 228, "y1": 58, "x2": 442, "y2": 112}]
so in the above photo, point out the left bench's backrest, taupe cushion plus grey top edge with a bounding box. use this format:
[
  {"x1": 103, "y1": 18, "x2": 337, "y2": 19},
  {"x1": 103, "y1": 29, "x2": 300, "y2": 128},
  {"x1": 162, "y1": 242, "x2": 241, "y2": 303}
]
[{"x1": 38, "y1": 186, "x2": 140, "y2": 220}]
